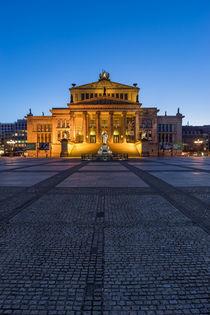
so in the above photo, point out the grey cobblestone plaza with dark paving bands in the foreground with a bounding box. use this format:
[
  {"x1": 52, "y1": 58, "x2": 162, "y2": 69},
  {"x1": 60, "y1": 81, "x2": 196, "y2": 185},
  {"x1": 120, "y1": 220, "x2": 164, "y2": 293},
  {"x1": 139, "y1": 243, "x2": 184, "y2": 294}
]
[{"x1": 0, "y1": 157, "x2": 210, "y2": 315}]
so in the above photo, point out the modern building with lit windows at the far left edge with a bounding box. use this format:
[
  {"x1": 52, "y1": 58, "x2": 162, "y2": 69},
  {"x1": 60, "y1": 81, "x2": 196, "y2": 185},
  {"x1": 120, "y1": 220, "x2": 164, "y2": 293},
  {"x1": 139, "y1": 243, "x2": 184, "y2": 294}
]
[{"x1": 0, "y1": 119, "x2": 27, "y2": 153}]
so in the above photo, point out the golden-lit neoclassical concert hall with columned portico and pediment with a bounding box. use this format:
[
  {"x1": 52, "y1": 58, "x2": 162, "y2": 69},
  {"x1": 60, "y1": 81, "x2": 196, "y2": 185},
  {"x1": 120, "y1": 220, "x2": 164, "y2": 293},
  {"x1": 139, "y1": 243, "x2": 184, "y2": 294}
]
[{"x1": 26, "y1": 71, "x2": 183, "y2": 157}]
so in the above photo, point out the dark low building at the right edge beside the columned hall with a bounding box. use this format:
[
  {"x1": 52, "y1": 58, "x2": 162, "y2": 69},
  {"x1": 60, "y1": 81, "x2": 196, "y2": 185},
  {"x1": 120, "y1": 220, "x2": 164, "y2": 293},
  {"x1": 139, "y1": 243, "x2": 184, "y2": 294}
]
[{"x1": 182, "y1": 125, "x2": 210, "y2": 155}]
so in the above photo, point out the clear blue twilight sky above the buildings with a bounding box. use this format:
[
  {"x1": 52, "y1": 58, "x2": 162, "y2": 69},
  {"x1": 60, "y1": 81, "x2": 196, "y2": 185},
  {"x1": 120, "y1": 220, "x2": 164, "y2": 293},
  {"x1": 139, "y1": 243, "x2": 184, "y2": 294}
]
[{"x1": 0, "y1": 0, "x2": 210, "y2": 125}]
